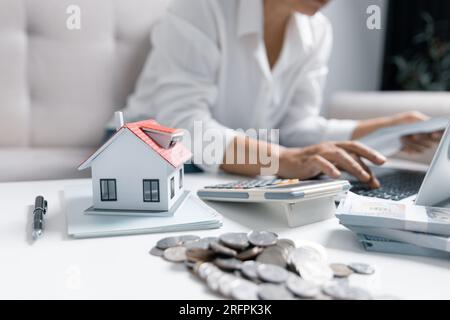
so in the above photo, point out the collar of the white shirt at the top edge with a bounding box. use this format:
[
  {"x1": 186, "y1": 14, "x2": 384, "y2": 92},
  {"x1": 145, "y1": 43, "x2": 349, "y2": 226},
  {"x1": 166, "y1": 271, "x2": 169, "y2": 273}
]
[{"x1": 237, "y1": 0, "x2": 264, "y2": 37}]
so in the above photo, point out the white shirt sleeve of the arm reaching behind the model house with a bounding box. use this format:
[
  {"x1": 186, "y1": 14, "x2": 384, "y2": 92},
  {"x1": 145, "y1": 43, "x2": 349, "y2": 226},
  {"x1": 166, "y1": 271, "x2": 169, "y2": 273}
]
[{"x1": 119, "y1": 0, "x2": 237, "y2": 171}]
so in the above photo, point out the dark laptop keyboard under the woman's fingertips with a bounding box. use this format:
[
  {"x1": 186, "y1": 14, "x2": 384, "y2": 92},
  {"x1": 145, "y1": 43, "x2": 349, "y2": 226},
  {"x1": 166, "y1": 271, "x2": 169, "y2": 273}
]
[{"x1": 351, "y1": 171, "x2": 425, "y2": 201}]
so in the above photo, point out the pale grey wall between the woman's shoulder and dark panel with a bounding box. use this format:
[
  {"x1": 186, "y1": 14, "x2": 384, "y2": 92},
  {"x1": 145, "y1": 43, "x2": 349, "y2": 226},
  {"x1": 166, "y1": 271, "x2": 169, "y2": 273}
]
[{"x1": 323, "y1": 0, "x2": 387, "y2": 113}]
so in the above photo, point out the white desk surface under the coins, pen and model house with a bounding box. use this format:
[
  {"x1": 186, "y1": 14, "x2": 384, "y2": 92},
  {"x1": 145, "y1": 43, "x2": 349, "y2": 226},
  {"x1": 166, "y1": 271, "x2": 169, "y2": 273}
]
[{"x1": 0, "y1": 174, "x2": 450, "y2": 299}]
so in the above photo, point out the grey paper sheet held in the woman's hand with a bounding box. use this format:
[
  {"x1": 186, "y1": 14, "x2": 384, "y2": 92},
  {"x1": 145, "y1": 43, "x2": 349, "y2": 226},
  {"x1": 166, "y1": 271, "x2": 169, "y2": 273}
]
[{"x1": 359, "y1": 117, "x2": 450, "y2": 157}]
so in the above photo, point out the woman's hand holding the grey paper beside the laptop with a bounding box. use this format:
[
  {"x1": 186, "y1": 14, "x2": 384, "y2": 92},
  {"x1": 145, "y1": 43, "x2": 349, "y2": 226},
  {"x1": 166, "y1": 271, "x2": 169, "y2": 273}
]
[{"x1": 352, "y1": 111, "x2": 443, "y2": 153}]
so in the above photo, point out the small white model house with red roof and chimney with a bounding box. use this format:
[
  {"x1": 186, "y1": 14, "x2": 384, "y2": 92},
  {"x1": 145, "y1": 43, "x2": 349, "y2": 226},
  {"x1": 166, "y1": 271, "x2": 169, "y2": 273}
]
[{"x1": 78, "y1": 114, "x2": 191, "y2": 211}]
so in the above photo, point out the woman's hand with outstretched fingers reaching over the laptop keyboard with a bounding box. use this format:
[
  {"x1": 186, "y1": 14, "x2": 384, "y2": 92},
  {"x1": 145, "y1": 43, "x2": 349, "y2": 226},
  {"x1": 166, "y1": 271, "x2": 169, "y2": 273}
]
[{"x1": 278, "y1": 141, "x2": 386, "y2": 188}]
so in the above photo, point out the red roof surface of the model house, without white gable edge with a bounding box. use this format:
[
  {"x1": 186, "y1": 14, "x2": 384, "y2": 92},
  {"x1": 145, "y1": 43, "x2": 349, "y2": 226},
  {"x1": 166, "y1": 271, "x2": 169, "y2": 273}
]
[{"x1": 124, "y1": 120, "x2": 192, "y2": 168}]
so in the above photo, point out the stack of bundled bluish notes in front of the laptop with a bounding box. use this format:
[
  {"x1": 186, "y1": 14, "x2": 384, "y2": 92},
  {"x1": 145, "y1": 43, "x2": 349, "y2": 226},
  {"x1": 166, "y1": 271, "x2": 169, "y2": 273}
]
[{"x1": 336, "y1": 193, "x2": 450, "y2": 256}]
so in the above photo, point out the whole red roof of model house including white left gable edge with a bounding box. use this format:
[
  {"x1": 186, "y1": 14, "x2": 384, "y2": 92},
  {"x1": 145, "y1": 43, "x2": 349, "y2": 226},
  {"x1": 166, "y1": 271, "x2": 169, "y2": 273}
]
[{"x1": 78, "y1": 120, "x2": 192, "y2": 170}]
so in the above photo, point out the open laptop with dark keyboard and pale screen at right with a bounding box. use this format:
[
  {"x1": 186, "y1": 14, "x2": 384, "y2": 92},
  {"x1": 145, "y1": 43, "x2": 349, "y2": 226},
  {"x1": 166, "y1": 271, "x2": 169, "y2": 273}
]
[{"x1": 349, "y1": 125, "x2": 450, "y2": 207}]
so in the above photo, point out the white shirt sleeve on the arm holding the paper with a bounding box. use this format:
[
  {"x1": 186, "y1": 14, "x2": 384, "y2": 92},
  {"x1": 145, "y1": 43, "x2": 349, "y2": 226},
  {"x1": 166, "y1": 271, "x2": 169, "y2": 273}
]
[{"x1": 280, "y1": 17, "x2": 357, "y2": 147}]
